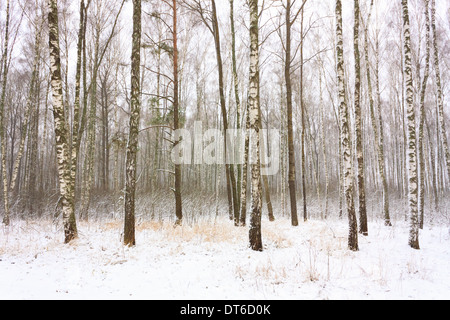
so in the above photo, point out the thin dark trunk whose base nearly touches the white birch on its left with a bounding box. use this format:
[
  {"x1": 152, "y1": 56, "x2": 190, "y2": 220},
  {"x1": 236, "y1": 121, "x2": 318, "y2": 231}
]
[{"x1": 353, "y1": 0, "x2": 369, "y2": 236}]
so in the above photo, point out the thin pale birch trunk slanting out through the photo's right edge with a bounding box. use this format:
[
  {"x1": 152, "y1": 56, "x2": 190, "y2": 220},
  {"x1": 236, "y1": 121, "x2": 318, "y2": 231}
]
[{"x1": 431, "y1": 0, "x2": 450, "y2": 181}]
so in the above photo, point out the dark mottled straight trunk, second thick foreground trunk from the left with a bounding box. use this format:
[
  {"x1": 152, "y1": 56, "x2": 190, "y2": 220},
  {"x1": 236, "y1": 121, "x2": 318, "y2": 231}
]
[{"x1": 124, "y1": 0, "x2": 142, "y2": 246}]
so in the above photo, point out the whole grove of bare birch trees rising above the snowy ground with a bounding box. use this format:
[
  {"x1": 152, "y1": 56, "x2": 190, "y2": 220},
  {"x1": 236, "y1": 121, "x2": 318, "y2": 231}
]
[{"x1": 0, "y1": 0, "x2": 450, "y2": 252}]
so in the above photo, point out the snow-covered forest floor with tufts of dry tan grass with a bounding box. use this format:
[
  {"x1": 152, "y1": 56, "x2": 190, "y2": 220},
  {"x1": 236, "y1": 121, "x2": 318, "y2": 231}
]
[{"x1": 0, "y1": 218, "x2": 450, "y2": 300}]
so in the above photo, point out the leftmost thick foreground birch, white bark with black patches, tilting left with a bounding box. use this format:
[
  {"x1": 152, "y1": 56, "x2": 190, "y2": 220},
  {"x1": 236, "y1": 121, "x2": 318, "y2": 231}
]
[{"x1": 48, "y1": 0, "x2": 78, "y2": 243}]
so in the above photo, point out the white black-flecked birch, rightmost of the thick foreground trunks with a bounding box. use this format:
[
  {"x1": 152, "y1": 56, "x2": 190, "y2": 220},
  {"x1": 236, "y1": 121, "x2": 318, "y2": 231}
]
[{"x1": 402, "y1": 0, "x2": 420, "y2": 249}]
